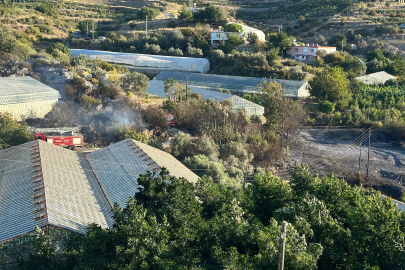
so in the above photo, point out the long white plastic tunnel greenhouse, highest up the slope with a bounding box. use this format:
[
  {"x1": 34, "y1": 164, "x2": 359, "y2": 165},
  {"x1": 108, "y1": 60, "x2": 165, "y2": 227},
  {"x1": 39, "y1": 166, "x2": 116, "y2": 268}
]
[{"x1": 70, "y1": 49, "x2": 210, "y2": 73}]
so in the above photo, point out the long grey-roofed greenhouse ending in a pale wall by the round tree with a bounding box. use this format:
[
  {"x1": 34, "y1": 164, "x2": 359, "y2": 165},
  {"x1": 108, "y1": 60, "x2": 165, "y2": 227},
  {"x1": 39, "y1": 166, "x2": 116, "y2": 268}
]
[{"x1": 154, "y1": 71, "x2": 310, "y2": 98}]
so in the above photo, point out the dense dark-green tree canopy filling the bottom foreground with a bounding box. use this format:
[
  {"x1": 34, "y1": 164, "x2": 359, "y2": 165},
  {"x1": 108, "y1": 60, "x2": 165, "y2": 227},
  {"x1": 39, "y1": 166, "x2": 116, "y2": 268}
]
[{"x1": 19, "y1": 166, "x2": 405, "y2": 270}]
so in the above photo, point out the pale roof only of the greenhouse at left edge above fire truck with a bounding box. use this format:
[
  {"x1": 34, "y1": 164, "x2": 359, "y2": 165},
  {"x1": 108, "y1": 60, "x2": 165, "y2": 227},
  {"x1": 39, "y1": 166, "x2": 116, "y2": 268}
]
[{"x1": 0, "y1": 77, "x2": 60, "y2": 105}]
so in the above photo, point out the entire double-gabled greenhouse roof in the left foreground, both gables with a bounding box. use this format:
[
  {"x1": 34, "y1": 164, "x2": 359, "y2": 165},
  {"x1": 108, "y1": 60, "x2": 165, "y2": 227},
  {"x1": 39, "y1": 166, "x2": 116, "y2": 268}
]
[{"x1": 0, "y1": 139, "x2": 198, "y2": 243}]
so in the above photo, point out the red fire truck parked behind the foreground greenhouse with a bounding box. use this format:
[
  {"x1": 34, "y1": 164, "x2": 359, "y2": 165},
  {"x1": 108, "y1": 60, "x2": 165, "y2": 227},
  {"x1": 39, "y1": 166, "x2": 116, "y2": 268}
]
[{"x1": 28, "y1": 127, "x2": 83, "y2": 149}]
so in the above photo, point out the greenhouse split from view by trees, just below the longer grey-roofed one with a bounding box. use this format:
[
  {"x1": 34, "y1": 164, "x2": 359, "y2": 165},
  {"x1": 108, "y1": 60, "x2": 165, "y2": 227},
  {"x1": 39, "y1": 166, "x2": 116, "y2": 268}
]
[{"x1": 146, "y1": 80, "x2": 264, "y2": 115}]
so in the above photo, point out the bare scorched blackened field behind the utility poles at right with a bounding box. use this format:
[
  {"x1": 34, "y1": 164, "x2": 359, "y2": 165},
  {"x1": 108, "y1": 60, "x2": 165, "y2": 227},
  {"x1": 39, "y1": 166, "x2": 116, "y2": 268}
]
[{"x1": 289, "y1": 129, "x2": 405, "y2": 198}]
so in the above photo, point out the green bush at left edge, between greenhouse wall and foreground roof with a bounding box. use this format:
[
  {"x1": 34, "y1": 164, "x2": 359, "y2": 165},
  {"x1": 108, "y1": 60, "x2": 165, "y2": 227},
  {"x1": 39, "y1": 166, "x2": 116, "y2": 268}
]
[{"x1": 0, "y1": 114, "x2": 31, "y2": 149}]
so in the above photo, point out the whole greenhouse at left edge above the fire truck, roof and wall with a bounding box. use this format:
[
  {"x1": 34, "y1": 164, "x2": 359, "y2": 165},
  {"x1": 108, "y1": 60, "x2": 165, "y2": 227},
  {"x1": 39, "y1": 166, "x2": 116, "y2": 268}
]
[{"x1": 0, "y1": 77, "x2": 60, "y2": 121}]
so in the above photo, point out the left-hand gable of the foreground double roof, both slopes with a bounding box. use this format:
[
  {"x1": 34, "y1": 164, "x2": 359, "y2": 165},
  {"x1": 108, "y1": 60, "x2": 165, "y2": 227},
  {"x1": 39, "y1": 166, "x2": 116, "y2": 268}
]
[{"x1": 0, "y1": 141, "x2": 113, "y2": 242}]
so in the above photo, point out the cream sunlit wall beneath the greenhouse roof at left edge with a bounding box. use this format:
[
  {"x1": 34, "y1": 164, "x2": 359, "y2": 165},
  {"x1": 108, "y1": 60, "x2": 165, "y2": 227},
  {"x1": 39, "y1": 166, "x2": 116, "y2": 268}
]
[{"x1": 0, "y1": 99, "x2": 58, "y2": 121}]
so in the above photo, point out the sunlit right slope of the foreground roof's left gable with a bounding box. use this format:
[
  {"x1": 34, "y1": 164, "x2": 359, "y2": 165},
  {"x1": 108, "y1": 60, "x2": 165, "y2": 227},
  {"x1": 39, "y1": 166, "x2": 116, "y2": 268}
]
[{"x1": 39, "y1": 141, "x2": 113, "y2": 233}]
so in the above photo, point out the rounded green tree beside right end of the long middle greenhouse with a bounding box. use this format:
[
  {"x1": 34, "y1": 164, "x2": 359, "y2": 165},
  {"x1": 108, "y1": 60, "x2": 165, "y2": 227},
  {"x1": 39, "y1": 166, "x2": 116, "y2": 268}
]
[{"x1": 309, "y1": 67, "x2": 351, "y2": 106}]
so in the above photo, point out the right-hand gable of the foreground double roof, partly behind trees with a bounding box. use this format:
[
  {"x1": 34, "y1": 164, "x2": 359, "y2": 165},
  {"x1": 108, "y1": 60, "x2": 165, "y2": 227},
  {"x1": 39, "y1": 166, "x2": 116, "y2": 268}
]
[{"x1": 87, "y1": 139, "x2": 198, "y2": 207}]
